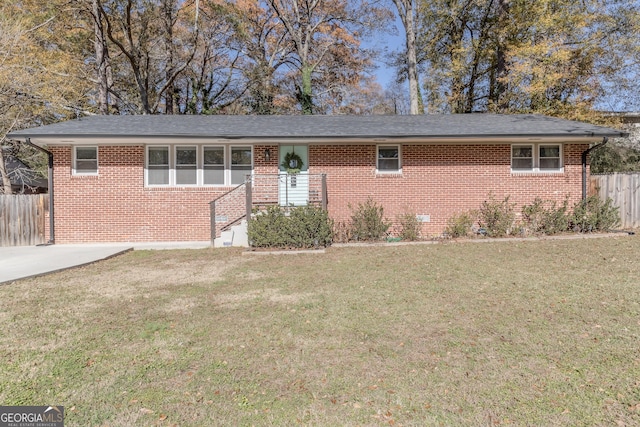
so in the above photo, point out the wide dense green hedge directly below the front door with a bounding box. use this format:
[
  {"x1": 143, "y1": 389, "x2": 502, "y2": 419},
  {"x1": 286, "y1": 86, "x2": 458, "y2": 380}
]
[{"x1": 247, "y1": 206, "x2": 333, "y2": 249}]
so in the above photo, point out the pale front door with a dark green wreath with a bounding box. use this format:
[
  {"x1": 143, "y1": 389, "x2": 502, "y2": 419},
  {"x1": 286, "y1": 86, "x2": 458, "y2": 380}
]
[{"x1": 278, "y1": 145, "x2": 309, "y2": 206}]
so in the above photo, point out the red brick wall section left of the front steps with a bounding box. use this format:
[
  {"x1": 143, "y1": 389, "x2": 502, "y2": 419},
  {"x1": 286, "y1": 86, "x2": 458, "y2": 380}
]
[{"x1": 50, "y1": 146, "x2": 231, "y2": 243}]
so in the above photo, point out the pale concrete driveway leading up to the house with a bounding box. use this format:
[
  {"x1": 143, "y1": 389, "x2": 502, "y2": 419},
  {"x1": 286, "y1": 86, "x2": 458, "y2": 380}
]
[{"x1": 0, "y1": 242, "x2": 211, "y2": 285}]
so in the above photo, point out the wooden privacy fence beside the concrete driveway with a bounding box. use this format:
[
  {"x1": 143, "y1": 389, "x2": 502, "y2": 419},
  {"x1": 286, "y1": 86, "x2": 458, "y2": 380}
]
[{"x1": 0, "y1": 194, "x2": 47, "y2": 246}]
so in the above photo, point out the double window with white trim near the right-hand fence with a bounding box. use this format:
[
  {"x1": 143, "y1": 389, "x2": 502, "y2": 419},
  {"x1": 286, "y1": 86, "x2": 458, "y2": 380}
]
[{"x1": 511, "y1": 143, "x2": 563, "y2": 172}]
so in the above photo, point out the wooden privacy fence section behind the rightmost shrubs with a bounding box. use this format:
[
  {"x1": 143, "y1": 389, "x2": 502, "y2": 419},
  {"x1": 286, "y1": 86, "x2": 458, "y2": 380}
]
[{"x1": 589, "y1": 173, "x2": 640, "y2": 228}]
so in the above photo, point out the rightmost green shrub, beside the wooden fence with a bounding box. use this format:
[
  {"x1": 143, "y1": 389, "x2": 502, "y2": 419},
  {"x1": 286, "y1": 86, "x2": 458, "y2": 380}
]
[{"x1": 571, "y1": 195, "x2": 620, "y2": 233}]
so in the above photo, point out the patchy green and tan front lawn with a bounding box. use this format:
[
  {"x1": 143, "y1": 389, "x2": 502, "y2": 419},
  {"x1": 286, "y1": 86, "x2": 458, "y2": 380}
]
[{"x1": 0, "y1": 237, "x2": 640, "y2": 426}]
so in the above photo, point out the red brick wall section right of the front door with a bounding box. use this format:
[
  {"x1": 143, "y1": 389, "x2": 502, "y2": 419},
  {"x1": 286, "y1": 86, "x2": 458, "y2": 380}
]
[{"x1": 309, "y1": 144, "x2": 588, "y2": 236}]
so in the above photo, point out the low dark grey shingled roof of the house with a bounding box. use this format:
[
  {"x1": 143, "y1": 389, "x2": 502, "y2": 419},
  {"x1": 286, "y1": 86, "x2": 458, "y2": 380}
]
[{"x1": 8, "y1": 114, "x2": 626, "y2": 140}]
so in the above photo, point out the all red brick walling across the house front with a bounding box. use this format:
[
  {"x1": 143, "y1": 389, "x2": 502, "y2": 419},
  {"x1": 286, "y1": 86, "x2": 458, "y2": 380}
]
[{"x1": 50, "y1": 144, "x2": 588, "y2": 243}]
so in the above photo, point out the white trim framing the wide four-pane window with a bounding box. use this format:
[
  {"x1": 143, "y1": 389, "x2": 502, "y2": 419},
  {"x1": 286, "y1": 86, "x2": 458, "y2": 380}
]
[{"x1": 144, "y1": 144, "x2": 255, "y2": 188}]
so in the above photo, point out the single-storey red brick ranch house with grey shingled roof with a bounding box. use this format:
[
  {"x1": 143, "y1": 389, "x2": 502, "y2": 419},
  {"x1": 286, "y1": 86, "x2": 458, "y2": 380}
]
[{"x1": 9, "y1": 114, "x2": 626, "y2": 243}]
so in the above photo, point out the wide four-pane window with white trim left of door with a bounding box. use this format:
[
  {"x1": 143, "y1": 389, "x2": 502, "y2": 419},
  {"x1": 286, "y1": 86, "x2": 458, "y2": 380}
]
[{"x1": 145, "y1": 144, "x2": 253, "y2": 186}]
